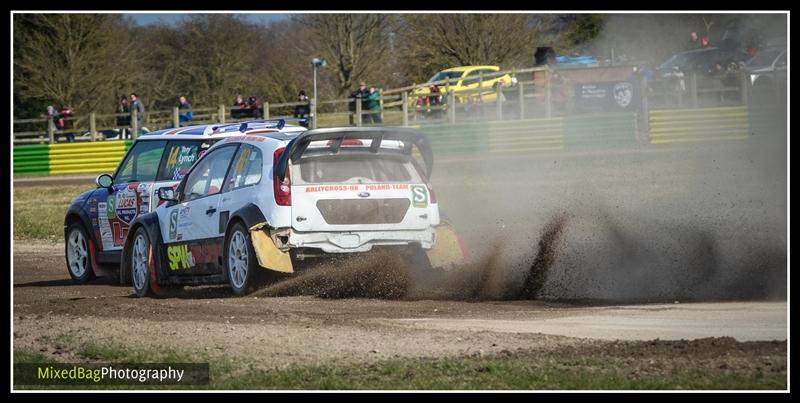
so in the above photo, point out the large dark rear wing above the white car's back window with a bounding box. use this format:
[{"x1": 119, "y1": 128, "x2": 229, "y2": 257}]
[{"x1": 275, "y1": 127, "x2": 433, "y2": 181}]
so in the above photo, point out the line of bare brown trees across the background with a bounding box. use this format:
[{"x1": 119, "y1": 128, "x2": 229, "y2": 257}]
[{"x1": 13, "y1": 13, "x2": 788, "y2": 118}]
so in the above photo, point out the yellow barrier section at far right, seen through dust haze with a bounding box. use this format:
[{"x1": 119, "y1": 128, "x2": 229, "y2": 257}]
[{"x1": 649, "y1": 106, "x2": 751, "y2": 144}]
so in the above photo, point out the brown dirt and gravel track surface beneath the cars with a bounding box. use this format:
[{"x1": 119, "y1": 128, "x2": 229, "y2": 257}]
[{"x1": 14, "y1": 243, "x2": 786, "y2": 366}]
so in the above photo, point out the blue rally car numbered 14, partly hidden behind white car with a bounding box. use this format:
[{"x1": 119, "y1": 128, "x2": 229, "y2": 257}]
[{"x1": 64, "y1": 119, "x2": 306, "y2": 283}]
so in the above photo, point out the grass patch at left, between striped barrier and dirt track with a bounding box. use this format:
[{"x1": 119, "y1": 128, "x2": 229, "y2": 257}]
[{"x1": 14, "y1": 185, "x2": 91, "y2": 242}]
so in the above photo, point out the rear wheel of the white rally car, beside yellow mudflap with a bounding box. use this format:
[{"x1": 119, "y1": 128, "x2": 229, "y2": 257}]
[{"x1": 225, "y1": 223, "x2": 263, "y2": 295}]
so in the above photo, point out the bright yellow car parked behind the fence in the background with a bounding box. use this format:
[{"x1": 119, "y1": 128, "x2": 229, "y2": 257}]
[{"x1": 410, "y1": 66, "x2": 511, "y2": 103}]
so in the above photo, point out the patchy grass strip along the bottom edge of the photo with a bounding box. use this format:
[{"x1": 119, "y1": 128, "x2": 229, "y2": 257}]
[{"x1": 14, "y1": 341, "x2": 787, "y2": 390}]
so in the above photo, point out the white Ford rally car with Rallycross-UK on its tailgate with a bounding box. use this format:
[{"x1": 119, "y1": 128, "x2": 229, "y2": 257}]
[{"x1": 121, "y1": 127, "x2": 465, "y2": 296}]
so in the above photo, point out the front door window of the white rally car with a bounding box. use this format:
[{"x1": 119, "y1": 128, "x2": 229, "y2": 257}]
[{"x1": 182, "y1": 145, "x2": 237, "y2": 202}]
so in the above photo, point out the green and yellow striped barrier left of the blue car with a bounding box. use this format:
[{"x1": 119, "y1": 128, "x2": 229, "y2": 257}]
[{"x1": 14, "y1": 140, "x2": 132, "y2": 174}]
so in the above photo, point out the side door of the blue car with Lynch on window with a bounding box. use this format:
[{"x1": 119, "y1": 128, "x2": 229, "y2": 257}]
[{"x1": 96, "y1": 140, "x2": 167, "y2": 251}]
